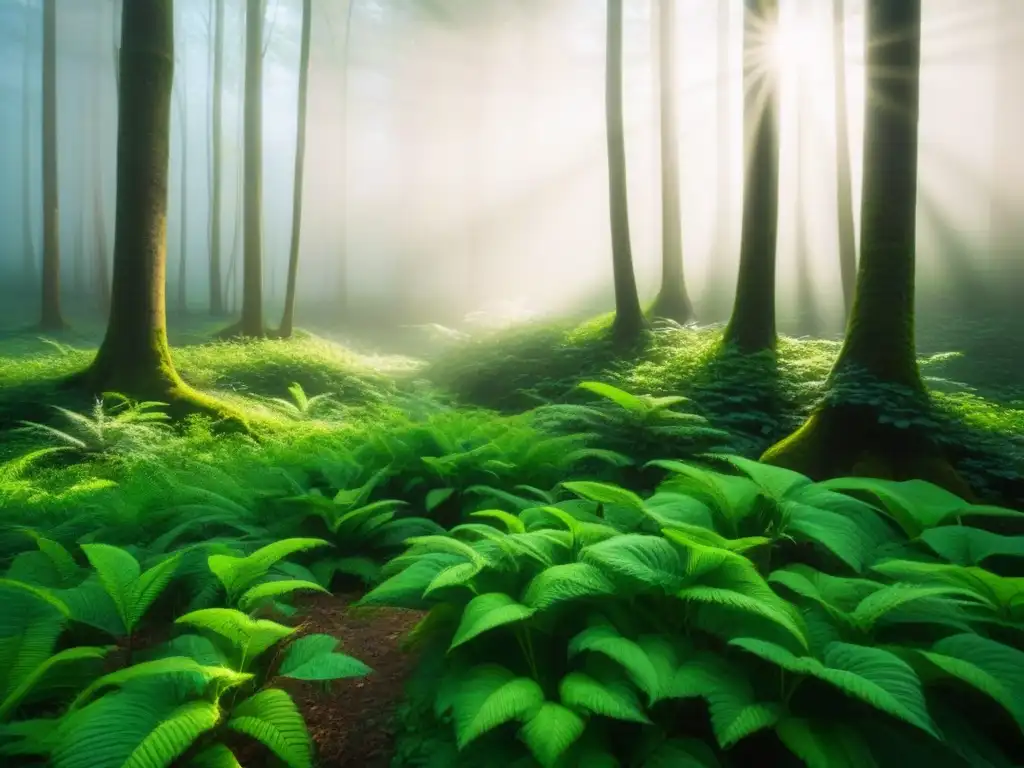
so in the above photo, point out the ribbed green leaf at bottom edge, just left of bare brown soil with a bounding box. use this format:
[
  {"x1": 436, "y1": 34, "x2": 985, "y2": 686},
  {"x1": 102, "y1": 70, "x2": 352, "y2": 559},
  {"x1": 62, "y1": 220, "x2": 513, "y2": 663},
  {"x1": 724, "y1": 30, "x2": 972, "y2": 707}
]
[{"x1": 227, "y1": 688, "x2": 313, "y2": 768}]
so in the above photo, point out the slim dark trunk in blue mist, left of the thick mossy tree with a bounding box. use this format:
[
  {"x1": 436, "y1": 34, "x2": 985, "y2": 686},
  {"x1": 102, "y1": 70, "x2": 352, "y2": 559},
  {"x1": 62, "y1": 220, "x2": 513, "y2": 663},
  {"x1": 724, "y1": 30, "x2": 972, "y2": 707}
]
[{"x1": 40, "y1": 0, "x2": 67, "y2": 331}]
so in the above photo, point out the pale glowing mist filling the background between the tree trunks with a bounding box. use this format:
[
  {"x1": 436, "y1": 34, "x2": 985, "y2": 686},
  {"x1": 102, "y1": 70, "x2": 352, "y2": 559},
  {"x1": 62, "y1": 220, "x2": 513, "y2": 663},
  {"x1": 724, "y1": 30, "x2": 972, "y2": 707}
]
[{"x1": 0, "y1": 0, "x2": 1024, "y2": 342}]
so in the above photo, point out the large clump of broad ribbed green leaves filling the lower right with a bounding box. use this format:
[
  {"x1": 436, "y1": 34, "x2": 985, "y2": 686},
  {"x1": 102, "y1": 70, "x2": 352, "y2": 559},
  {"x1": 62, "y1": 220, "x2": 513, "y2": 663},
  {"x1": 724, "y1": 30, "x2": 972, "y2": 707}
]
[{"x1": 376, "y1": 456, "x2": 1024, "y2": 768}]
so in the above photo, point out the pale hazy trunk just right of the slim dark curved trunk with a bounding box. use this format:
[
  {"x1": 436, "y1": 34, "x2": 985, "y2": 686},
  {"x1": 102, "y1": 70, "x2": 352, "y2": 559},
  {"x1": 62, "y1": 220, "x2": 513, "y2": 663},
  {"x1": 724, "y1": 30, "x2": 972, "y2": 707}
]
[{"x1": 651, "y1": 0, "x2": 693, "y2": 323}]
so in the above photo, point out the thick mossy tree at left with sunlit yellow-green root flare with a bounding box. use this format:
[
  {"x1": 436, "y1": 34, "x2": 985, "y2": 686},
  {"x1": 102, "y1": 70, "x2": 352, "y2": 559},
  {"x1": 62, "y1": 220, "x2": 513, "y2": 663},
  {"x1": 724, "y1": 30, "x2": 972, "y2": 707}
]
[{"x1": 77, "y1": 0, "x2": 222, "y2": 421}]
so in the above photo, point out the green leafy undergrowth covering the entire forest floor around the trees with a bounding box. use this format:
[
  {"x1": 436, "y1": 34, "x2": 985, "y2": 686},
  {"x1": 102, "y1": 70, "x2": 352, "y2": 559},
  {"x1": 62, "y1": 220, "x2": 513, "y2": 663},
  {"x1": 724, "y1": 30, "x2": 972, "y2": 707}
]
[{"x1": 0, "y1": 322, "x2": 1024, "y2": 768}]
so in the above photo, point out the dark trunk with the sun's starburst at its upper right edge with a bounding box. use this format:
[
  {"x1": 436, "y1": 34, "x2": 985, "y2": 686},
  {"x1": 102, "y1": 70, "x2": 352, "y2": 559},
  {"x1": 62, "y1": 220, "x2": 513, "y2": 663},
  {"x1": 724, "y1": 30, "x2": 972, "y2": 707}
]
[{"x1": 725, "y1": 0, "x2": 778, "y2": 353}]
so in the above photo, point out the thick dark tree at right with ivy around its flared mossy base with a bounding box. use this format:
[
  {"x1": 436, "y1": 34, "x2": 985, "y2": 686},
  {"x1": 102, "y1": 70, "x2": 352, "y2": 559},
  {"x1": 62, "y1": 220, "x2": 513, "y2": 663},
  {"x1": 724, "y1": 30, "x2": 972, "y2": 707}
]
[{"x1": 762, "y1": 0, "x2": 970, "y2": 495}]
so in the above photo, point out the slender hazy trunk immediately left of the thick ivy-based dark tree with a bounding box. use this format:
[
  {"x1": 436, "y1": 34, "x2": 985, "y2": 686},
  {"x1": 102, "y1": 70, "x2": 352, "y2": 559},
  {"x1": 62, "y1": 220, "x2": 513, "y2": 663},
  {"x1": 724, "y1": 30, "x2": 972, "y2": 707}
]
[{"x1": 833, "y1": 0, "x2": 857, "y2": 322}]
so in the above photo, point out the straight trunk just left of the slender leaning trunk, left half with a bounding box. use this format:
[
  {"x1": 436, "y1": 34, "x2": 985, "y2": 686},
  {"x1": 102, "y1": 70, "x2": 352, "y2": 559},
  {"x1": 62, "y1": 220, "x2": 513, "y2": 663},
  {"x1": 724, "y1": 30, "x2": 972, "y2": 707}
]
[{"x1": 221, "y1": 0, "x2": 266, "y2": 338}]
